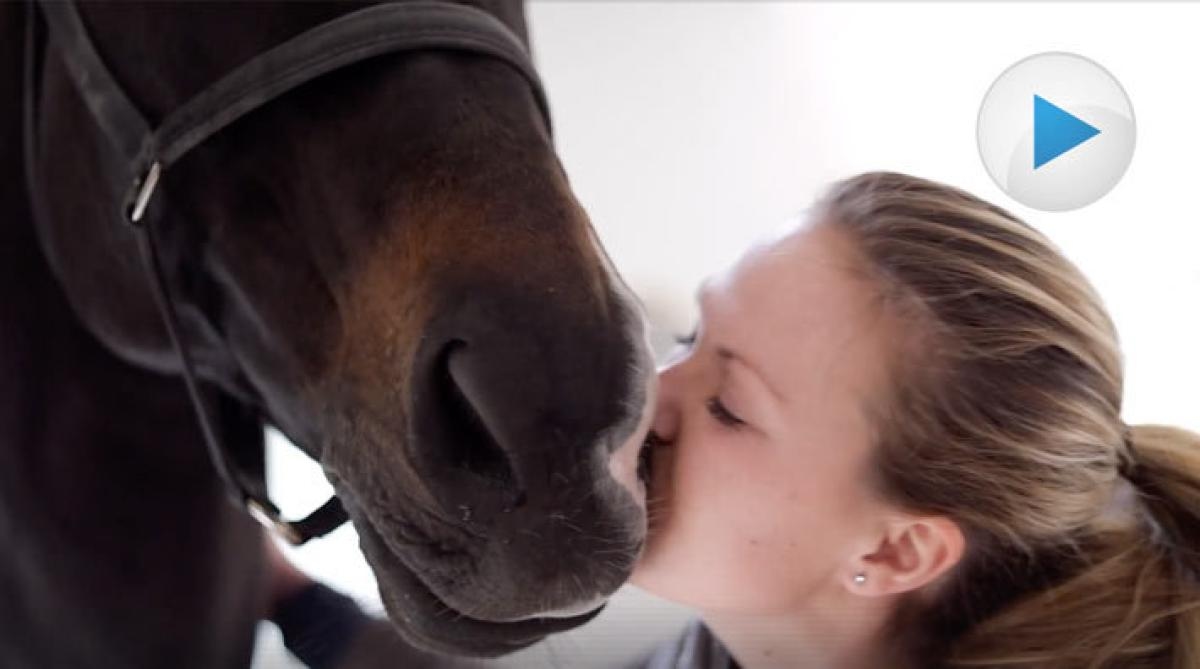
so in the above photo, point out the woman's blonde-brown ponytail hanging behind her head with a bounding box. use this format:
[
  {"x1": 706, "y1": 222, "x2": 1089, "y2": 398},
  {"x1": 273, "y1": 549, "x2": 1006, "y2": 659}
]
[{"x1": 944, "y1": 426, "x2": 1200, "y2": 669}]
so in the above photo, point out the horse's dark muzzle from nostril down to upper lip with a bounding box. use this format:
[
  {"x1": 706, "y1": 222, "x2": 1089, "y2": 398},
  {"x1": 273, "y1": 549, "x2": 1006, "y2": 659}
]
[{"x1": 403, "y1": 284, "x2": 656, "y2": 621}]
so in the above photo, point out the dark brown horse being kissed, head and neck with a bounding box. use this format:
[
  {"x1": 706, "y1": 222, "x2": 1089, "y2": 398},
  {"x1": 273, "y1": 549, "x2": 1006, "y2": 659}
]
[{"x1": 0, "y1": 0, "x2": 655, "y2": 668}]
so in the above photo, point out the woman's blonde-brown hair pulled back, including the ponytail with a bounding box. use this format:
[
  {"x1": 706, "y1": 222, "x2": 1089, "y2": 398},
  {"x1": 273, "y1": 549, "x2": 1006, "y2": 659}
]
[{"x1": 816, "y1": 173, "x2": 1200, "y2": 669}]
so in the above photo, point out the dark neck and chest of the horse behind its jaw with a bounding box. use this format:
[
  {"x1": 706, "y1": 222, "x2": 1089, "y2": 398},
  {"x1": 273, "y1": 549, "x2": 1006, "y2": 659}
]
[{"x1": 0, "y1": 11, "x2": 262, "y2": 667}]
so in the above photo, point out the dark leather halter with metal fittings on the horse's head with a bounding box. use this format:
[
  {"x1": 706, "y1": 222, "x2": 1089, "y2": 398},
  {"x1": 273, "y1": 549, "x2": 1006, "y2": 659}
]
[{"x1": 24, "y1": 0, "x2": 550, "y2": 546}]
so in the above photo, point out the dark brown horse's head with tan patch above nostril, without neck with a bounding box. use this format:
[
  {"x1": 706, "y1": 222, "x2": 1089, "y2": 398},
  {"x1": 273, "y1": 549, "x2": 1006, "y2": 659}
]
[{"x1": 36, "y1": 2, "x2": 654, "y2": 655}]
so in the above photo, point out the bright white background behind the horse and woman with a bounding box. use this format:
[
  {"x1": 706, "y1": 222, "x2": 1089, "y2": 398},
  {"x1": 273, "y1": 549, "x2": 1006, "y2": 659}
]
[{"x1": 250, "y1": 1, "x2": 1200, "y2": 668}]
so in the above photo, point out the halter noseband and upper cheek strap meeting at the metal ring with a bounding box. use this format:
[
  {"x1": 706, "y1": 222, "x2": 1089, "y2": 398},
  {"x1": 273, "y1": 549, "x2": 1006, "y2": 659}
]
[{"x1": 38, "y1": 0, "x2": 550, "y2": 223}]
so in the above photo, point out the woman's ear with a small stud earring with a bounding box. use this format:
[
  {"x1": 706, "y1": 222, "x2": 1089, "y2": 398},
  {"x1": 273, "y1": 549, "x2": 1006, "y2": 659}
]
[{"x1": 845, "y1": 516, "x2": 966, "y2": 597}]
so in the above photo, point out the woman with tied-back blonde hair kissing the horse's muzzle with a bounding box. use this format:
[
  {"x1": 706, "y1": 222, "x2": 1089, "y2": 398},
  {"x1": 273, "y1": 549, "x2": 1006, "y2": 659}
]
[{"x1": 265, "y1": 173, "x2": 1200, "y2": 669}]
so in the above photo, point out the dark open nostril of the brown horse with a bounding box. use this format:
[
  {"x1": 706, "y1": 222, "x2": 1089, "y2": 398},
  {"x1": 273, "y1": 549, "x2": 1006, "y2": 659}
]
[{"x1": 436, "y1": 340, "x2": 515, "y2": 488}]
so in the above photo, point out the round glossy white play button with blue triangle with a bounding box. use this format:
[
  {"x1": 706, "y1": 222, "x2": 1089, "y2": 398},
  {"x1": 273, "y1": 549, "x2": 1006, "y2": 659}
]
[{"x1": 976, "y1": 53, "x2": 1135, "y2": 211}]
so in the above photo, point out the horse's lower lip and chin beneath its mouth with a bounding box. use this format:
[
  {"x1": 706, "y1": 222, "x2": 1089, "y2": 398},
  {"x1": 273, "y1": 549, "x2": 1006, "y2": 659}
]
[{"x1": 356, "y1": 522, "x2": 604, "y2": 657}]
